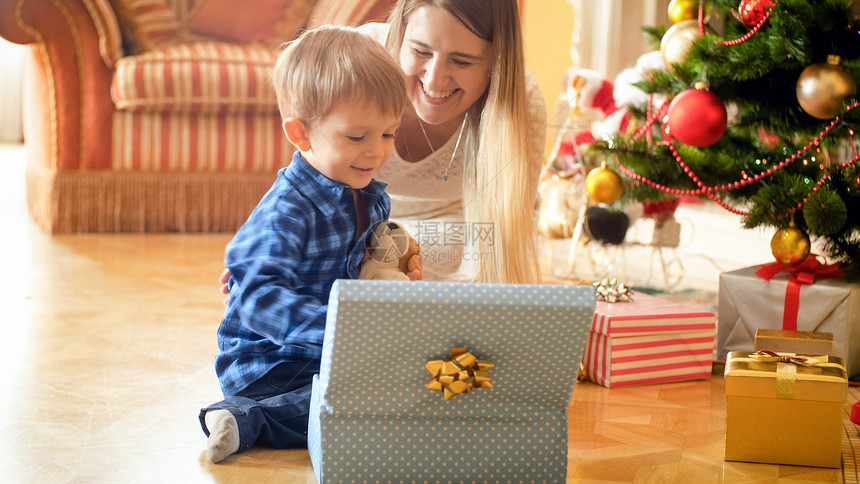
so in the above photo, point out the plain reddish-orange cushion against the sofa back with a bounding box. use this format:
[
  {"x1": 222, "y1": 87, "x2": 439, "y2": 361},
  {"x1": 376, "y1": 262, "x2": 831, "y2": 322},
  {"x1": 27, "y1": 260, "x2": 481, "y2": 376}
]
[{"x1": 188, "y1": 0, "x2": 317, "y2": 48}]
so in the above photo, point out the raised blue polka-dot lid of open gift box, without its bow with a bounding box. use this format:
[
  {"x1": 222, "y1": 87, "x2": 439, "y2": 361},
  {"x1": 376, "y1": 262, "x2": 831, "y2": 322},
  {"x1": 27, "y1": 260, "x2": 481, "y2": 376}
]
[{"x1": 319, "y1": 280, "x2": 595, "y2": 419}]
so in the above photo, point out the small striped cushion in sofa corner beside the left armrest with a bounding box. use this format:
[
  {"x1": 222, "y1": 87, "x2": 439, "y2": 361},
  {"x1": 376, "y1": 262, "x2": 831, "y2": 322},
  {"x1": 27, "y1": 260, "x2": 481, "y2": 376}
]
[{"x1": 110, "y1": 0, "x2": 179, "y2": 54}]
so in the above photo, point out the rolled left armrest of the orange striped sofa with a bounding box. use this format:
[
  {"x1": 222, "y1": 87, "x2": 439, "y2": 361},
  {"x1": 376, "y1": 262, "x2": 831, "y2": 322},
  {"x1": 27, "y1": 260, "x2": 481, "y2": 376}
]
[{"x1": 0, "y1": 0, "x2": 122, "y2": 169}]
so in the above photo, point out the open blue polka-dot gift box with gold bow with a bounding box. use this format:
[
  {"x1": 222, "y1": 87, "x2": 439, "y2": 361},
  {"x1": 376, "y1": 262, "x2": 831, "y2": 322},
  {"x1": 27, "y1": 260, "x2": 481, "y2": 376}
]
[{"x1": 308, "y1": 280, "x2": 595, "y2": 484}]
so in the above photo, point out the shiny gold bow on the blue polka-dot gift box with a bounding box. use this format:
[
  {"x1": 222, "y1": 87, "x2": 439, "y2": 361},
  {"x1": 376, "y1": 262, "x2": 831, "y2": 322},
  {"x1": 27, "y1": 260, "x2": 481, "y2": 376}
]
[{"x1": 424, "y1": 347, "x2": 493, "y2": 402}]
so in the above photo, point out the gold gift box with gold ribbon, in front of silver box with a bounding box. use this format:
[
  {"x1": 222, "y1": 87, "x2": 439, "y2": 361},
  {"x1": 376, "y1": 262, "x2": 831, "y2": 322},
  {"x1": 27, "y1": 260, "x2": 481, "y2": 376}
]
[{"x1": 725, "y1": 351, "x2": 848, "y2": 468}]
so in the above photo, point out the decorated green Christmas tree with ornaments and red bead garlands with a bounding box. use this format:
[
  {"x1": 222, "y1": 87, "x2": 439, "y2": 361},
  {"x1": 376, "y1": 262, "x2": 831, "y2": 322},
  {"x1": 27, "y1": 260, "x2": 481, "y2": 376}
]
[{"x1": 595, "y1": 0, "x2": 860, "y2": 269}]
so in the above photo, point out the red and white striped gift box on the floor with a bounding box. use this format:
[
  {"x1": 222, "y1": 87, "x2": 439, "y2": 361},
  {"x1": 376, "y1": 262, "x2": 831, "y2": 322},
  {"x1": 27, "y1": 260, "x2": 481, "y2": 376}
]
[{"x1": 583, "y1": 292, "x2": 716, "y2": 388}]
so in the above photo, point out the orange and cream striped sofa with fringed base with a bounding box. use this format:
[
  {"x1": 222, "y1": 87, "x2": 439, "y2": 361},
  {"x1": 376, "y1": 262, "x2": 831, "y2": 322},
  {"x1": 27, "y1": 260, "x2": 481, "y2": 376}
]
[{"x1": 0, "y1": 0, "x2": 394, "y2": 233}]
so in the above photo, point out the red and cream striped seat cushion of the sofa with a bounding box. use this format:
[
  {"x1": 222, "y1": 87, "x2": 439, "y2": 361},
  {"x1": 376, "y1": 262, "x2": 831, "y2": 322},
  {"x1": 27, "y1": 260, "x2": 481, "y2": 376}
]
[{"x1": 111, "y1": 42, "x2": 278, "y2": 113}]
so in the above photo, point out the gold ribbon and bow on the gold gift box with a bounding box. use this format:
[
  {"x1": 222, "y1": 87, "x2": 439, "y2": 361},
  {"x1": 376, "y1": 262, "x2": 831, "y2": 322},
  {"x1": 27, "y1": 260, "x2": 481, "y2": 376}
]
[{"x1": 731, "y1": 350, "x2": 845, "y2": 400}]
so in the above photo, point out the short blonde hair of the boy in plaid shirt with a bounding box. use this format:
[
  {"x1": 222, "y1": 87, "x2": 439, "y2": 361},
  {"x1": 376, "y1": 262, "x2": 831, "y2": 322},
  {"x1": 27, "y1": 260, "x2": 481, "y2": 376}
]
[{"x1": 272, "y1": 26, "x2": 409, "y2": 123}]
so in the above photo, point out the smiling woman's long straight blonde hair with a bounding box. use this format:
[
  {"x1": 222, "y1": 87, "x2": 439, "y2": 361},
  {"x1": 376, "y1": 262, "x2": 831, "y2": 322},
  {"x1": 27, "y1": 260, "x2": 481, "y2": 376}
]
[{"x1": 386, "y1": 0, "x2": 542, "y2": 283}]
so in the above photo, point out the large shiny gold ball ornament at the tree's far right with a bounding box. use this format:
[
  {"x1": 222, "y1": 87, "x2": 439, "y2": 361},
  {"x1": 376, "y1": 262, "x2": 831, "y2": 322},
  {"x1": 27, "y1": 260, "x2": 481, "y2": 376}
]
[{"x1": 797, "y1": 55, "x2": 856, "y2": 119}]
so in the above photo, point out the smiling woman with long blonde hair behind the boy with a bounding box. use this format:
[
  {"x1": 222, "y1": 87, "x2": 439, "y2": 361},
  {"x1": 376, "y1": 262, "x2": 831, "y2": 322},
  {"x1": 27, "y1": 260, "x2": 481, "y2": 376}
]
[{"x1": 368, "y1": 0, "x2": 546, "y2": 283}]
